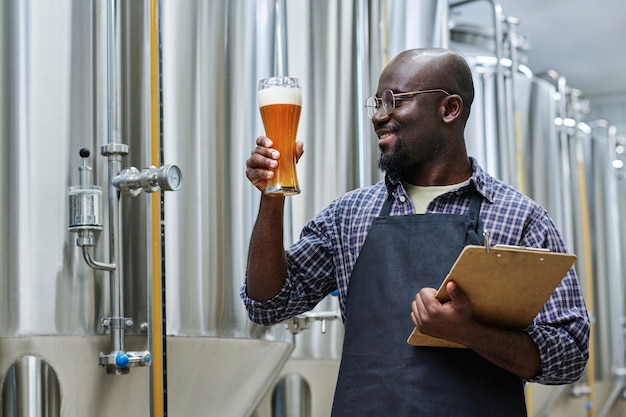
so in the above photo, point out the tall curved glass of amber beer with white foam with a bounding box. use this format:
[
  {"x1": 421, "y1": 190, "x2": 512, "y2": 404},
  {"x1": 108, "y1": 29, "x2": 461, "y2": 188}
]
[{"x1": 258, "y1": 77, "x2": 302, "y2": 195}]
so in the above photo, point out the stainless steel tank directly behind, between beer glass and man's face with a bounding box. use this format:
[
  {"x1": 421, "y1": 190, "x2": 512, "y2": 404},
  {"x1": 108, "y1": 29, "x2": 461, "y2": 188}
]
[{"x1": 254, "y1": 0, "x2": 447, "y2": 417}]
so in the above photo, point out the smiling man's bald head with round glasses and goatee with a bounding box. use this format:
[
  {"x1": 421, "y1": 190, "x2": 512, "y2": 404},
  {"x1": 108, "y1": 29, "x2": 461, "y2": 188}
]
[{"x1": 372, "y1": 48, "x2": 474, "y2": 185}]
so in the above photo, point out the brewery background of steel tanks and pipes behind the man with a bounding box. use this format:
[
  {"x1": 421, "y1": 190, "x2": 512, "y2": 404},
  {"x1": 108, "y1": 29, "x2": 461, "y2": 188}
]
[{"x1": 0, "y1": 0, "x2": 626, "y2": 417}]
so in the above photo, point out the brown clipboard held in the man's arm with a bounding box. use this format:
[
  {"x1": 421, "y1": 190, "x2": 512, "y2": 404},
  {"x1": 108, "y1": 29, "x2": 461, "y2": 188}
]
[{"x1": 407, "y1": 245, "x2": 576, "y2": 348}]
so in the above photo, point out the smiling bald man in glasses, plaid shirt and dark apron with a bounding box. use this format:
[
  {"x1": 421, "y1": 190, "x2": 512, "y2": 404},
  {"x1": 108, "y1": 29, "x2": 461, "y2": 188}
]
[{"x1": 241, "y1": 49, "x2": 589, "y2": 417}]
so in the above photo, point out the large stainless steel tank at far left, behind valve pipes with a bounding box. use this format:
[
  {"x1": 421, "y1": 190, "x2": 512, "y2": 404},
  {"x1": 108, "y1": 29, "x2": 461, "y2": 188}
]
[{"x1": 0, "y1": 0, "x2": 293, "y2": 417}]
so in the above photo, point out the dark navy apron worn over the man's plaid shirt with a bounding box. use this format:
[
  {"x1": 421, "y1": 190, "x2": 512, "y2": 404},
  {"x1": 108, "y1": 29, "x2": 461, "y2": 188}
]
[{"x1": 332, "y1": 190, "x2": 527, "y2": 417}]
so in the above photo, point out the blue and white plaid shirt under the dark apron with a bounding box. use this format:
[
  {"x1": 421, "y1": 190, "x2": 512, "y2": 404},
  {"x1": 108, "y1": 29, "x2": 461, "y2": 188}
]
[{"x1": 241, "y1": 159, "x2": 589, "y2": 384}]
